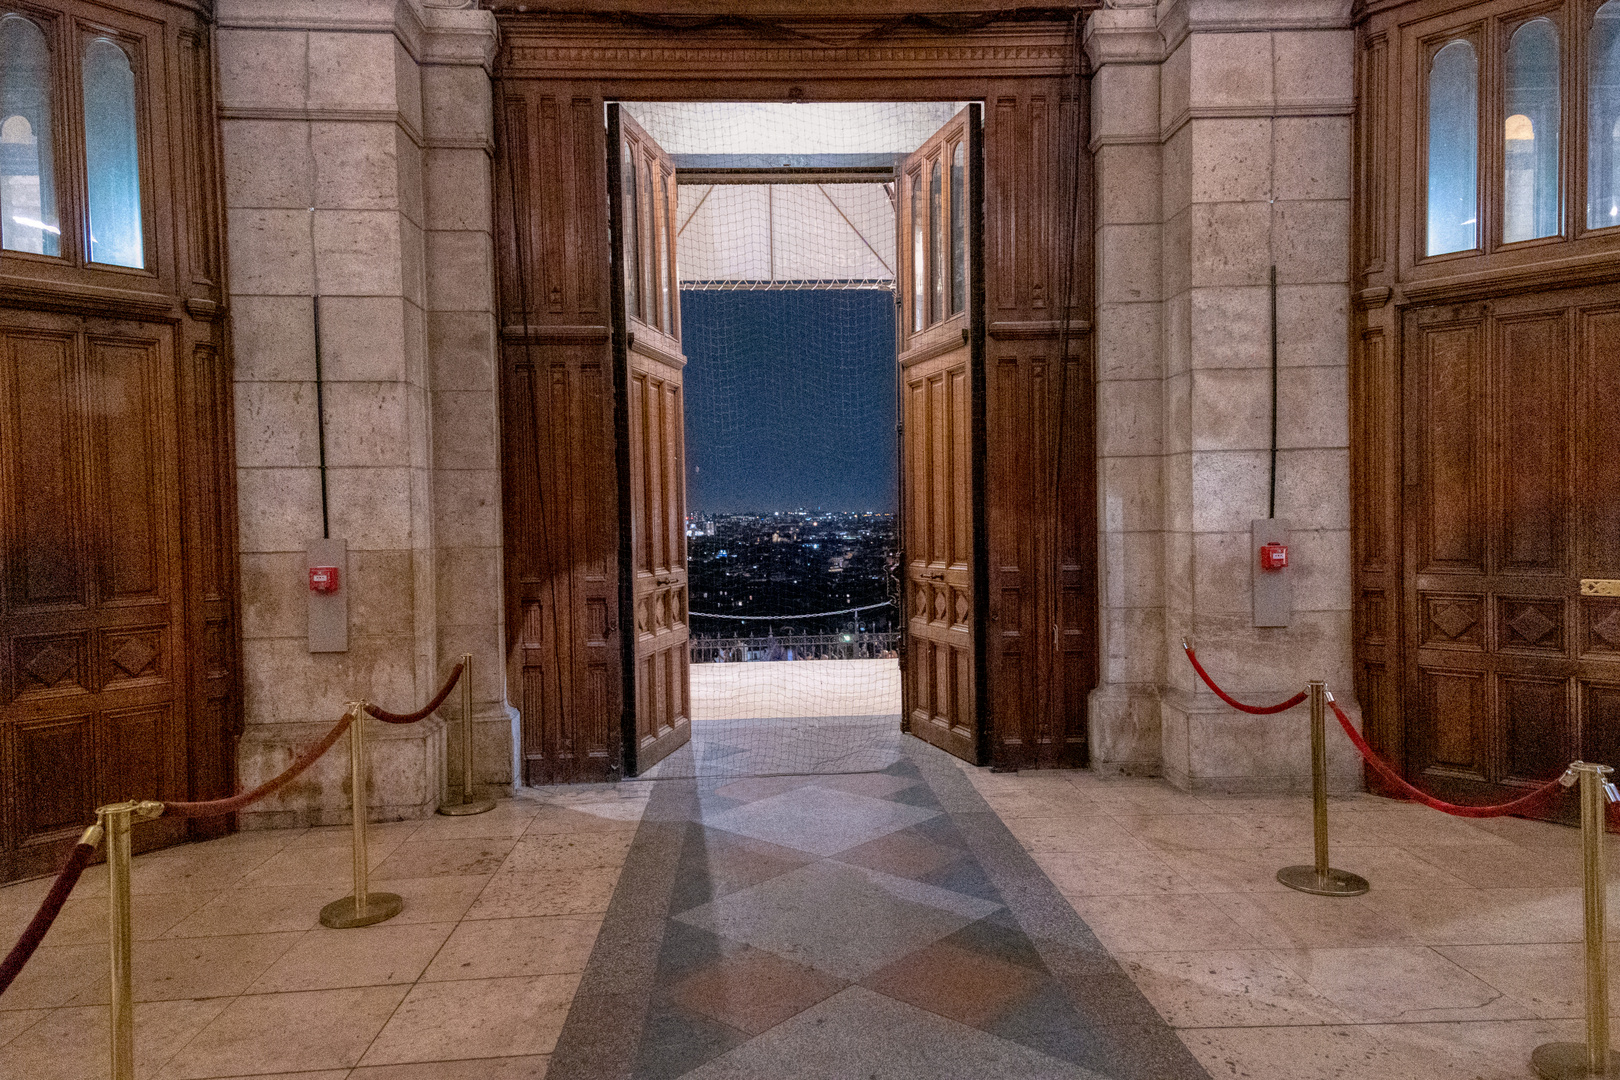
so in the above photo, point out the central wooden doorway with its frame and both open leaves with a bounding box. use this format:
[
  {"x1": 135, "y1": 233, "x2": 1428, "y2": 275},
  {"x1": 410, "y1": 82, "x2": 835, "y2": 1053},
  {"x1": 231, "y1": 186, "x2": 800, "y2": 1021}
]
[{"x1": 496, "y1": 3, "x2": 1098, "y2": 784}]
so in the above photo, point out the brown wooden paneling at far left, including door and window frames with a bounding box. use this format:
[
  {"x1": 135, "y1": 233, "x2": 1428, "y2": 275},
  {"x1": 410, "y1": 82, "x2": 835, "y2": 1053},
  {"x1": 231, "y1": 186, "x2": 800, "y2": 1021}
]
[{"x1": 0, "y1": 0, "x2": 241, "y2": 881}]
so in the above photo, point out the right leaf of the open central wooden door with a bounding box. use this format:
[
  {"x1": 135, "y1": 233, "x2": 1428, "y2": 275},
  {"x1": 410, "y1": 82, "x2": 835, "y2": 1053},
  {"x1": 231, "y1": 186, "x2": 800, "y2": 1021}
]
[{"x1": 894, "y1": 105, "x2": 990, "y2": 764}]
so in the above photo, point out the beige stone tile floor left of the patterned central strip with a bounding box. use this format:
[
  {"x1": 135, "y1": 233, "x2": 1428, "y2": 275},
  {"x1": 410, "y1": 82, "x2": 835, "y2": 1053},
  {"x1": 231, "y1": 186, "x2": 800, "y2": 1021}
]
[{"x1": 0, "y1": 784, "x2": 650, "y2": 1080}]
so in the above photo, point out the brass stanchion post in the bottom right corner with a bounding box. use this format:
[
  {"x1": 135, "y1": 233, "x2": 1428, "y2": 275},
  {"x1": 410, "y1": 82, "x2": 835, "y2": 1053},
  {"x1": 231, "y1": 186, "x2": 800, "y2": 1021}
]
[{"x1": 1529, "y1": 761, "x2": 1620, "y2": 1080}]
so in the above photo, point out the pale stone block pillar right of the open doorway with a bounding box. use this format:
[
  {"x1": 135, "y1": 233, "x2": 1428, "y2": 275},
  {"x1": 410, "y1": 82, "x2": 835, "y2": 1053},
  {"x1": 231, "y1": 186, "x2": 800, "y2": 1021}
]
[{"x1": 1089, "y1": 0, "x2": 1359, "y2": 790}]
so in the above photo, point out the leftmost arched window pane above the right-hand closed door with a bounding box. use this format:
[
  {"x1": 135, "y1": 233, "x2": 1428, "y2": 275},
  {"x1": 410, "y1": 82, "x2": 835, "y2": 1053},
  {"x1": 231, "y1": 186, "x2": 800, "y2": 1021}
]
[{"x1": 1427, "y1": 40, "x2": 1479, "y2": 254}]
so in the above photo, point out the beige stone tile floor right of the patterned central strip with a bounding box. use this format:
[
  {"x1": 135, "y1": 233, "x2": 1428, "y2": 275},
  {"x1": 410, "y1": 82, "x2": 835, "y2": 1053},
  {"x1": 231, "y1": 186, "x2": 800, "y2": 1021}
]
[{"x1": 969, "y1": 769, "x2": 1620, "y2": 1080}]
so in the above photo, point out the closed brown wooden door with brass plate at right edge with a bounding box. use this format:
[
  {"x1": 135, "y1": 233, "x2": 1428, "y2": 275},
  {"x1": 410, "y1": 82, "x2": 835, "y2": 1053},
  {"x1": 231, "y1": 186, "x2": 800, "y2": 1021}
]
[{"x1": 1403, "y1": 288, "x2": 1620, "y2": 809}]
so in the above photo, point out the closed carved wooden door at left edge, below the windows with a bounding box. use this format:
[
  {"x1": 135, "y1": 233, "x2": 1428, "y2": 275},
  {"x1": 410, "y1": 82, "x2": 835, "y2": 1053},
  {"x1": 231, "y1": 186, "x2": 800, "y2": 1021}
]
[{"x1": 0, "y1": 314, "x2": 190, "y2": 879}]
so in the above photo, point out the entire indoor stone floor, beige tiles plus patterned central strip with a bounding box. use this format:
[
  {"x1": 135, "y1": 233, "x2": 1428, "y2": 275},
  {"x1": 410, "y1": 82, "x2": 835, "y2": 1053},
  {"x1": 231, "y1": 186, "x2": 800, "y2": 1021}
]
[{"x1": 0, "y1": 740, "x2": 1620, "y2": 1080}]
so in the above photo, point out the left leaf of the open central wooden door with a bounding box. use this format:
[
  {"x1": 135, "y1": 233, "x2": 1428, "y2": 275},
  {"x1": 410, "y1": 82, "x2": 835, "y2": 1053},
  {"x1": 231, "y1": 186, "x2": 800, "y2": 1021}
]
[{"x1": 608, "y1": 104, "x2": 692, "y2": 776}]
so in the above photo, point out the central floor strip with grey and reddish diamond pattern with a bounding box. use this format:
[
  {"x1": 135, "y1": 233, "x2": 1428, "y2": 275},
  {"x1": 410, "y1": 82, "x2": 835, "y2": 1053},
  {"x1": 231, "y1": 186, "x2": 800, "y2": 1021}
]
[{"x1": 549, "y1": 740, "x2": 1207, "y2": 1080}]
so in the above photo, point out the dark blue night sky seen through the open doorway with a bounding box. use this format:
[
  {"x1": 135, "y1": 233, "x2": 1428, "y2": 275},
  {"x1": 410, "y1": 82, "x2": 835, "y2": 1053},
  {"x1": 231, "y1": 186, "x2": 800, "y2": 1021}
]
[{"x1": 680, "y1": 288, "x2": 894, "y2": 513}]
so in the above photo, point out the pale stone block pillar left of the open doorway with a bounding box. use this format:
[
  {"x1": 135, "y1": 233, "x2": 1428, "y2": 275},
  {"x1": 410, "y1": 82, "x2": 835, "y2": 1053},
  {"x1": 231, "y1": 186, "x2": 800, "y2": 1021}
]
[{"x1": 217, "y1": 0, "x2": 510, "y2": 827}]
